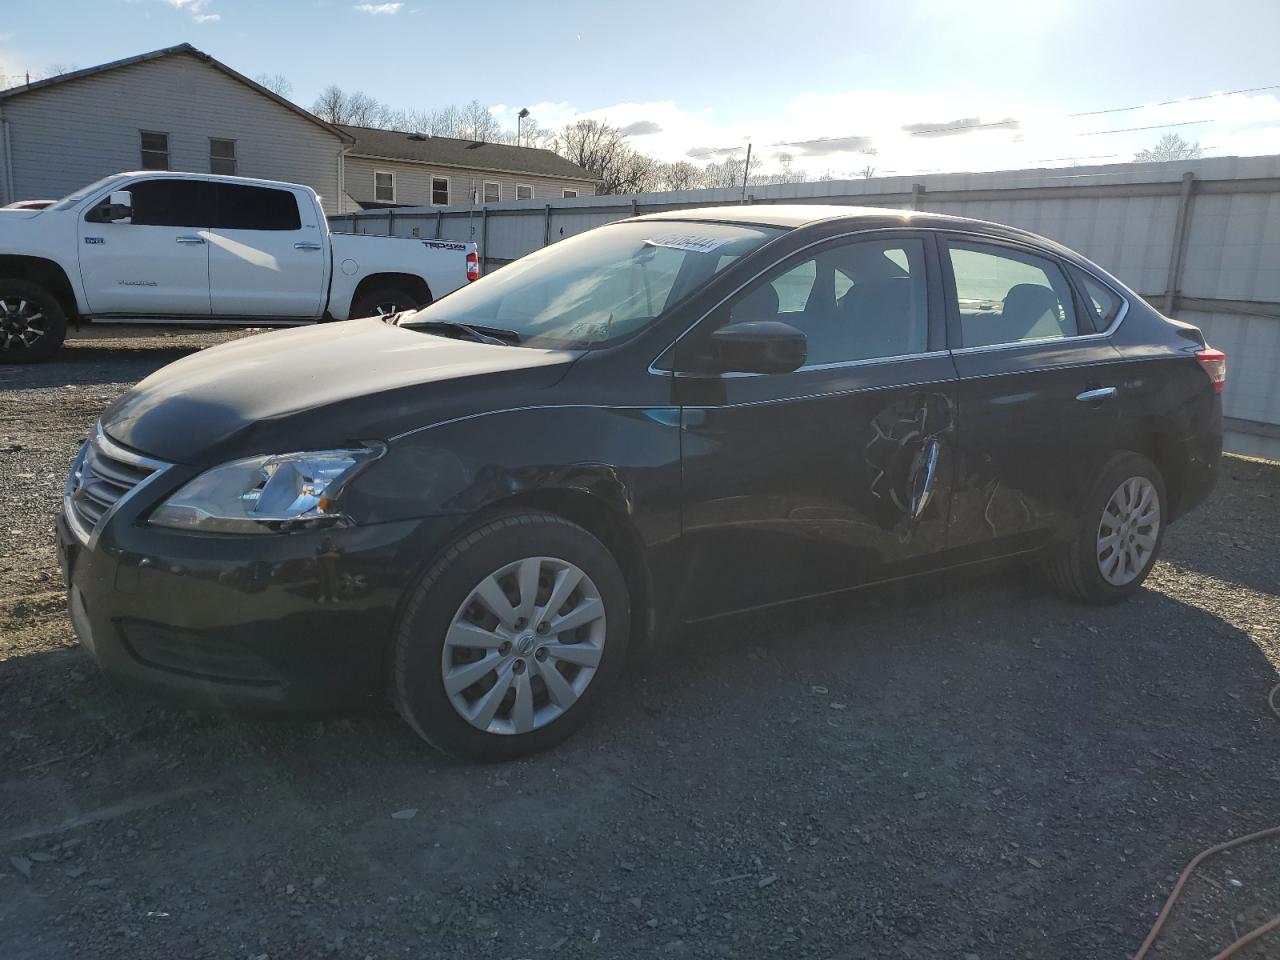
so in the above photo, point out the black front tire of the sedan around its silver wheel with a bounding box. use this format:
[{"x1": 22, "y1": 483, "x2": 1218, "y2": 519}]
[{"x1": 392, "y1": 512, "x2": 631, "y2": 762}]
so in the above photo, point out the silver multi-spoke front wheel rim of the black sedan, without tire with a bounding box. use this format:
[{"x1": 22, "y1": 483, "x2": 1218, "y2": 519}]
[{"x1": 442, "y1": 557, "x2": 605, "y2": 735}]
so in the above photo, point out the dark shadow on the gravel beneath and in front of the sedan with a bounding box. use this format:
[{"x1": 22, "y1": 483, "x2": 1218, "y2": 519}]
[{"x1": 0, "y1": 568, "x2": 1277, "y2": 957}]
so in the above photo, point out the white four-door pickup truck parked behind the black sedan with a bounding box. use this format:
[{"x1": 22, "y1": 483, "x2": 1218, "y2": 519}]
[{"x1": 0, "y1": 172, "x2": 480, "y2": 364}]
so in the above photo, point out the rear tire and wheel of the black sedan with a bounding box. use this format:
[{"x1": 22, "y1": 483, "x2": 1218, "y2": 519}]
[{"x1": 1043, "y1": 452, "x2": 1169, "y2": 604}]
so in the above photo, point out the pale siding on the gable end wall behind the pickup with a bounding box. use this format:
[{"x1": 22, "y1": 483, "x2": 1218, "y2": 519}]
[{"x1": 0, "y1": 54, "x2": 346, "y2": 214}]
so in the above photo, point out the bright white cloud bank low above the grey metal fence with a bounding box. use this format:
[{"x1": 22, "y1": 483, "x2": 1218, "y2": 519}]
[{"x1": 494, "y1": 90, "x2": 1280, "y2": 179}]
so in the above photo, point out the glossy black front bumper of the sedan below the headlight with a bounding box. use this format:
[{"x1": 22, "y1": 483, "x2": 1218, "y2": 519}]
[{"x1": 58, "y1": 517, "x2": 465, "y2": 712}]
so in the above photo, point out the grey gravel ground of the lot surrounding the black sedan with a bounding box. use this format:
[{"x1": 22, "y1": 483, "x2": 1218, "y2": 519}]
[{"x1": 0, "y1": 328, "x2": 1280, "y2": 960}]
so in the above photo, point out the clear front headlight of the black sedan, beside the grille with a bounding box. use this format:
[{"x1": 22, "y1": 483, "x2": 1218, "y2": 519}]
[{"x1": 150, "y1": 444, "x2": 387, "y2": 534}]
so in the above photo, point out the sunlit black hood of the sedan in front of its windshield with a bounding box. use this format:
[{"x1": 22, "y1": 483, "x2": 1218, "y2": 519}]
[{"x1": 102, "y1": 317, "x2": 580, "y2": 466}]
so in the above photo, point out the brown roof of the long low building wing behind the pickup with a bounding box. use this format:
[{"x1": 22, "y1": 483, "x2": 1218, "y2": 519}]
[{"x1": 338, "y1": 123, "x2": 595, "y2": 182}]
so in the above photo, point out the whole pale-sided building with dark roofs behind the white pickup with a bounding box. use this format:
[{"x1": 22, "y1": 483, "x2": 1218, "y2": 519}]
[{"x1": 0, "y1": 44, "x2": 595, "y2": 214}]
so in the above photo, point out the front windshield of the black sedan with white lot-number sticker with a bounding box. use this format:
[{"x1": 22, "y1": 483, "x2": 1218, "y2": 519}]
[{"x1": 401, "y1": 220, "x2": 782, "y2": 348}]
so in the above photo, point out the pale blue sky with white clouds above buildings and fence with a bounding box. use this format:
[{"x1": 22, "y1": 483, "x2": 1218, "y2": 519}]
[{"x1": 0, "y1": 0, "x2": 1280, "y2": 177}]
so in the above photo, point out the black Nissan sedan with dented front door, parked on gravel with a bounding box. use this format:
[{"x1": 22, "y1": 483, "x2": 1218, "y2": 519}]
[{"x1": 59, "y1": 206, "x2": 1225, "y2": 759}]
